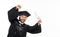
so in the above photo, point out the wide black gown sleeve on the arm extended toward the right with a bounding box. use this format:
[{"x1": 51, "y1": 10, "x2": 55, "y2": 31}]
[{"x1": 27, "y1": 23, "x2": 41, "y2": 34}]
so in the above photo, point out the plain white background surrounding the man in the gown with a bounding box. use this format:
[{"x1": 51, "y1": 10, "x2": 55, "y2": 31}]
[{"x1": 0, "y1": 0, "x2": 60, "y2": 37}]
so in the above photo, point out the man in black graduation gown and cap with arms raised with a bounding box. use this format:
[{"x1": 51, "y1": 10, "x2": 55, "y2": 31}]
[{"x1": 7, "y1": 5, "x2": 41, "y2": 37}]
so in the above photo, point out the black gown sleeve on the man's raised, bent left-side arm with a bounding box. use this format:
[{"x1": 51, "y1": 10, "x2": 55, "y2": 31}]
[{"x1": 8, "y1": 7, "x2": 18, "y2": 22}]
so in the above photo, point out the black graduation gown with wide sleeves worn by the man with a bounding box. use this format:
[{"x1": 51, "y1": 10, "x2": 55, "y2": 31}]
[{"x1": 7, "y1": 7, "x2": 41, "y2": 37}]
